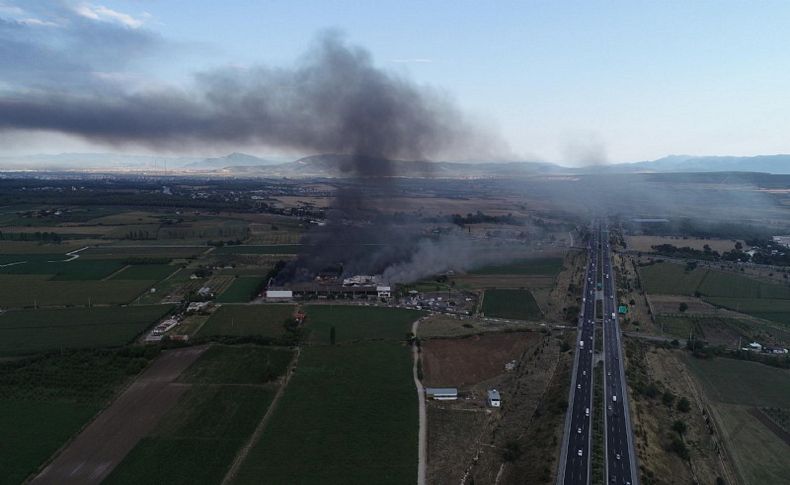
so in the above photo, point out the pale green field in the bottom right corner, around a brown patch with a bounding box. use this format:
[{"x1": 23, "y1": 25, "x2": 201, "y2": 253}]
[{"x1": 684, "y1": 356, "x2": 790, "y2": 484}]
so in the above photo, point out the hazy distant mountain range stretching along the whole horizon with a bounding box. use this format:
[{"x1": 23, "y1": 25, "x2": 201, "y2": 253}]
[{"x1": 0, "y1": 153, "x2": 790, "y2": 178}]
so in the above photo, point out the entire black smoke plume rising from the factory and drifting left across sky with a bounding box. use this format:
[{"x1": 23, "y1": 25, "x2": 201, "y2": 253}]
[{"x1": 0, "y1": 33, "x2": 496, "y2": 280}]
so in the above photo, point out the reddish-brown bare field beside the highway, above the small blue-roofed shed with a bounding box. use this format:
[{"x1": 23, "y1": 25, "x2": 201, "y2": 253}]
[{"x1": 421, "y1": 332, "x2": 542, "y2": 387}]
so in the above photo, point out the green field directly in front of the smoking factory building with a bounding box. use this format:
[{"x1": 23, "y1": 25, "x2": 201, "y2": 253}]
[{"x1": 305, "y1": 305, "x2": 424, "y2": 344}]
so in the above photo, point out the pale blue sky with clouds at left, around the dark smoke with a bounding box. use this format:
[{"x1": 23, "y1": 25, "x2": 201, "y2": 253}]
[{"x1": 0, "y1": 0, "x2": 790, "y2": 165}]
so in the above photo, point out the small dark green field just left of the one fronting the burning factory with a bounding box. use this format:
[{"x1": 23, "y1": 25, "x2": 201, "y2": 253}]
[{"x1": 197, "y1": 305, "x2": 295, "y2": 338}]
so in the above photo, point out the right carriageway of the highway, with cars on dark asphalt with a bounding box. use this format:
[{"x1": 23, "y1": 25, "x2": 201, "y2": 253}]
[{"x1": 600, "y1": 228, "x2": 638, "y2": 485}]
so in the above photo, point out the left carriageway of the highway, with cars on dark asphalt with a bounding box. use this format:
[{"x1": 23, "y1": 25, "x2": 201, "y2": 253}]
[{"x1": 557, "y1": 230, "x2": 599, "y2": 485}]
